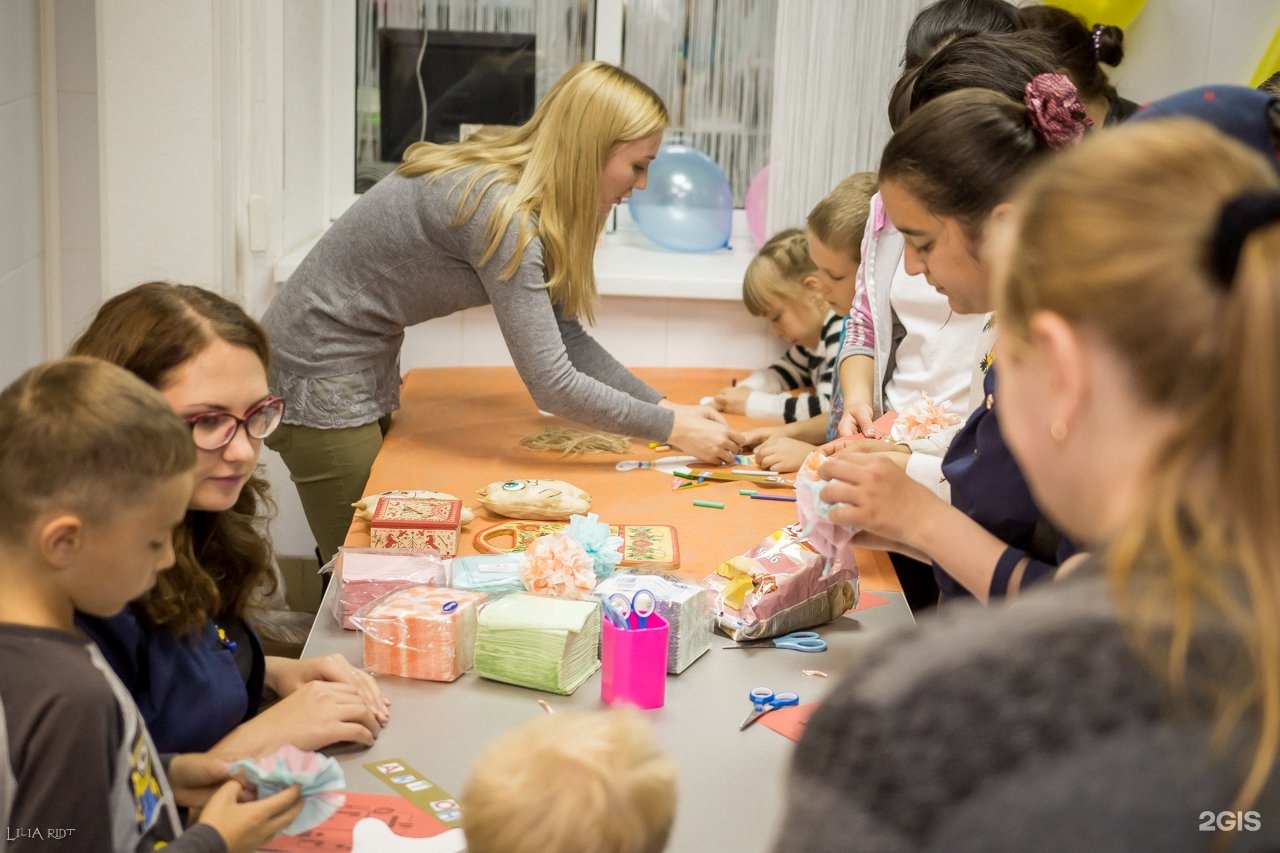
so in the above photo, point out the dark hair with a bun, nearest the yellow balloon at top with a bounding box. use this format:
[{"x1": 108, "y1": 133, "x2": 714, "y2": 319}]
[{"x1": 1018, "y1": 5, "x2": 1138, "y2": 127}]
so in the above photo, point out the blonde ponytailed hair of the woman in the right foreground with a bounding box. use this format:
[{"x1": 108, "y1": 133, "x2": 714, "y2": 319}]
[{"x1": 998, "y1": 119, "x2": 1280, "y2": 808}]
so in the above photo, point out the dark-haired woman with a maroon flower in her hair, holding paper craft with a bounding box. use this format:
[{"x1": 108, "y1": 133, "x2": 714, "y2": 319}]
[{"x1": 820, "y1": 74, "x2": 1088, "y2": 601}]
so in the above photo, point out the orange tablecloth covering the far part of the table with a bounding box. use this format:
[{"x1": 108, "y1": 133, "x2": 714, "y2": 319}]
[{"x1": 347, "y1": 368, "x2": 901, "y2": 590}]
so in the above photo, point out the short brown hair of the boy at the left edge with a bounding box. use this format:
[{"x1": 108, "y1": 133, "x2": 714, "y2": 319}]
[{"x1": 0, "y1": 357, "x2": 196, "y2": 544}]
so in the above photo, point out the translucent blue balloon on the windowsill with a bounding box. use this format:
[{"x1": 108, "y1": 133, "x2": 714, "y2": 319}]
[{"x1": 628, "y1": 145, "x2": 733, "y2": 252}]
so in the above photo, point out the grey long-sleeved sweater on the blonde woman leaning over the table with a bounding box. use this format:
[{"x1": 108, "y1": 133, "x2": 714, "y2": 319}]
[{"x1": 262, "y1": 170, "x2": 675, "y2": 441}]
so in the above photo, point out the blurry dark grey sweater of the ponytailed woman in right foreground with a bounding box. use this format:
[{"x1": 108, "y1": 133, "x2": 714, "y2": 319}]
[{"x1": 774, "y1": 567, "x2": 1280, "y2": 853}]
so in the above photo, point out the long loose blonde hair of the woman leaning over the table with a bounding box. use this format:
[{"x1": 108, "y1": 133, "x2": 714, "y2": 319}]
[{"x1": 397, "y1": 61, "x2": 671, "y2": 320}]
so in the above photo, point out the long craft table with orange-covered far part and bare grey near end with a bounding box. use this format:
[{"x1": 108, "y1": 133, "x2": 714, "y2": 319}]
[{"x1": 303, "y1": 368, "x2": 913, "y2": 853}]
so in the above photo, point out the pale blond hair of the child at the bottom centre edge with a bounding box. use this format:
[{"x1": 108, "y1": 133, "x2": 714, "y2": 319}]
[{"x1": 460, "y1": 708, "x2": 676, "y2": 853}]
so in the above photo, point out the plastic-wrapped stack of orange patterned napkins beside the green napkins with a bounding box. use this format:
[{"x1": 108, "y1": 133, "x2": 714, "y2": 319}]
[{"x1": 355, "y1": 587, "x2": 486, "y2": 681}]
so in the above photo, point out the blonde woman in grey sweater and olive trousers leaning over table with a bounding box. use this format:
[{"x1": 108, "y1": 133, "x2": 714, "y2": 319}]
[{"x1": 262, "y1": 61, "x2": 742, "y2": 558}]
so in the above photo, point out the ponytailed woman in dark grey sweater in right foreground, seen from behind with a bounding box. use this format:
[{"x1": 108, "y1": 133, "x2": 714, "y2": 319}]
[{"x1": 776, "y1": 119, "x2": 1280, "y2": 853}]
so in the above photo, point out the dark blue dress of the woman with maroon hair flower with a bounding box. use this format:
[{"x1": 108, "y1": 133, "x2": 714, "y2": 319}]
[{"x1": 933, "y1": 366, "x2": 1076, "y2": 601}]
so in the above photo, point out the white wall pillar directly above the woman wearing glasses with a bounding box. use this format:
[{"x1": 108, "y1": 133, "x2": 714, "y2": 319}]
[{"x1": 97, "y1": 0, "x2": 226, "y2": 293}]
